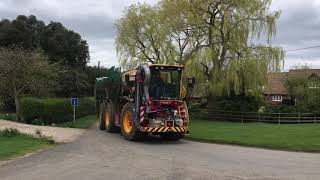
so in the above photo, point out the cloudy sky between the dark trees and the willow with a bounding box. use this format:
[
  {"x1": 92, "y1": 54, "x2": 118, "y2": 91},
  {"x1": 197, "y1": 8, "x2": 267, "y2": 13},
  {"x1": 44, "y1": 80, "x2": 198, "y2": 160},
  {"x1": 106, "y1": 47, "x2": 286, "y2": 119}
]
[{"x1": 0, "y1": 0, "x2": 157, "y2": 66}]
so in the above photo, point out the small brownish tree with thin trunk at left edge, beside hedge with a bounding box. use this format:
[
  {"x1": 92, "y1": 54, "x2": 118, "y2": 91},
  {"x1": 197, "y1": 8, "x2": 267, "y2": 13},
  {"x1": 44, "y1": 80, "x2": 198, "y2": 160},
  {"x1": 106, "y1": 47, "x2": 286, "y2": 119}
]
[{"x1": 0, "y1": 48, "x2": 57, "y2": 120}]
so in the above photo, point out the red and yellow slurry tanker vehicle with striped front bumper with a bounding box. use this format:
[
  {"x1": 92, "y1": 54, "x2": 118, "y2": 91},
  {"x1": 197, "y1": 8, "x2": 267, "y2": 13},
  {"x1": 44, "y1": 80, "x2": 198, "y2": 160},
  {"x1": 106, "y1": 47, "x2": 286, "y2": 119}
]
[{"x1": 95, "y1": 64, "x2": 194, "y2": 140}]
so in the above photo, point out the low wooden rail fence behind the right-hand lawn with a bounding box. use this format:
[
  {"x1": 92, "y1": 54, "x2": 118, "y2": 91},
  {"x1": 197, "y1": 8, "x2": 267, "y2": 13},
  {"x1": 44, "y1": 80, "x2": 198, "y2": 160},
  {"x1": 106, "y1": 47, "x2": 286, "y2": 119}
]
[{"x1": 190, "y1": 110, "x2": 320, "y2": 124}]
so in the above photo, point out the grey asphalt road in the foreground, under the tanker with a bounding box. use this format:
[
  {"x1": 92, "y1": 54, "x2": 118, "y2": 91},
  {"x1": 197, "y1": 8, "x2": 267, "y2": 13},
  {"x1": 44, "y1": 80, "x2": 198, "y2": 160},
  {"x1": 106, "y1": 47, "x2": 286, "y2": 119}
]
[{"x1": 0, "y1": 125, "x2": 320, "y2": 180}]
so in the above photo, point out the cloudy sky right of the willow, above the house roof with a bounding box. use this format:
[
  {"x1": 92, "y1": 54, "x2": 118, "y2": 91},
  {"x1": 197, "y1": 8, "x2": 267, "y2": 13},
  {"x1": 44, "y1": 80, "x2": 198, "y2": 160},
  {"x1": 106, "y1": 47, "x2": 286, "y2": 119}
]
[{"x1": 272, "y1": 0, "x2": 320, "y2": 69}]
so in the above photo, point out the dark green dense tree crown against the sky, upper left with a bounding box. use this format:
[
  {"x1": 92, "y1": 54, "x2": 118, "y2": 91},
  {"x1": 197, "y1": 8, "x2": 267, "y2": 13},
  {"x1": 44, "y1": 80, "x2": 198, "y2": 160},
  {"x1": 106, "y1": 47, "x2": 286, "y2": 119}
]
[{"x1": 0, "y1": 15, "x2": 90, "y2": 69}]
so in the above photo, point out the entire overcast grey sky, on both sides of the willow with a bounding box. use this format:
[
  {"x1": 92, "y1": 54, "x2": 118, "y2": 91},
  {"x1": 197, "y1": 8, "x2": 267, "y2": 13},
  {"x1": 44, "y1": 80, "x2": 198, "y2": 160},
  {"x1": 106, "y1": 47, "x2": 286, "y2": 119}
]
[{"x1": 0, "y1": 0, "x2": 320, "y2": 70}]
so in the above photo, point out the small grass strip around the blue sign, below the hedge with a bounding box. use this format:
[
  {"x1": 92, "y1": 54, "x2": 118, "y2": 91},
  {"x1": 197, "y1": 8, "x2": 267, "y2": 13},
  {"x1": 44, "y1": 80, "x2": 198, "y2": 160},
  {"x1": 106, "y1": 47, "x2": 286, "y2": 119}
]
[{"x1": 57, "y1": 115, "x2": 98, "y2": 129}]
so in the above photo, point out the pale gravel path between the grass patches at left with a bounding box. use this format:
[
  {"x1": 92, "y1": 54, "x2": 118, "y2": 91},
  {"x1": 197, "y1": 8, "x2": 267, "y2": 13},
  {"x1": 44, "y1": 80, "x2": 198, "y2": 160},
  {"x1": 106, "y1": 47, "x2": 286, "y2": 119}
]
[{"x1": 0, "y1": 120, "x2": 85, "y2": 143}]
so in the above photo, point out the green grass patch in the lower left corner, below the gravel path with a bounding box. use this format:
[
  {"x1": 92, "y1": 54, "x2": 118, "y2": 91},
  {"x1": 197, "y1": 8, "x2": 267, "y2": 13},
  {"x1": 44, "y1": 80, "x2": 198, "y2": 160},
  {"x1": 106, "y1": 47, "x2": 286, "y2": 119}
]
[{"x1": 0, "y1": 134, "x2": 52, "y2": 160}]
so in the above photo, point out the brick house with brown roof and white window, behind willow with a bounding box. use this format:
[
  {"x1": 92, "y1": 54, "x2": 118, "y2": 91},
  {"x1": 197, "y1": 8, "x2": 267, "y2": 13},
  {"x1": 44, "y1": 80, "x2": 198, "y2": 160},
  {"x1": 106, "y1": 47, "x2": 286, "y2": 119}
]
[{"x1": 263, "y1": 69, "x2": 320, "y2": 105}]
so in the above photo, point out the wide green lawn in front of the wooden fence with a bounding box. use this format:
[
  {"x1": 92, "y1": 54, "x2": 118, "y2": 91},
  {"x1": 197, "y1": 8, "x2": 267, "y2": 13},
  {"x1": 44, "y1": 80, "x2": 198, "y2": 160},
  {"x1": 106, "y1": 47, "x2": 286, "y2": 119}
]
[{"x1": 187, "y1": 120, "x2": 320, "y2": 152}]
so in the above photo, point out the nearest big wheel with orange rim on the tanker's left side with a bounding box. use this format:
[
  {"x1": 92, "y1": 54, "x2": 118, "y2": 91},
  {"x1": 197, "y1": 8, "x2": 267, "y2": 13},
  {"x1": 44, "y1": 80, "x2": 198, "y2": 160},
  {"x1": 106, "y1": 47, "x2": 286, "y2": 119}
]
[{"x1": 121, "y1": 103, "x2": 145, "y2": 141}]
